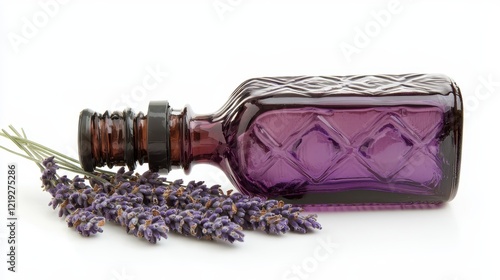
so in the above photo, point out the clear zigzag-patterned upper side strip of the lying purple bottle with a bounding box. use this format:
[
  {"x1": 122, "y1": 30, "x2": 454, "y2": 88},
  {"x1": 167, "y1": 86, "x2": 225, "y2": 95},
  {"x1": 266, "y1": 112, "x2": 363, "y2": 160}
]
[{"x1": 214, "y1": 74, "x2": 461, "y2": 119}]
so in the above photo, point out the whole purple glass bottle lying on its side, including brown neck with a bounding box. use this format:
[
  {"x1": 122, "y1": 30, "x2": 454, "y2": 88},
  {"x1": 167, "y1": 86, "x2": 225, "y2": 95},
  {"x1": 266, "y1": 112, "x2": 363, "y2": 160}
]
[{"x1": 79, "y1": 74, "x2": 463, "y2": 206}]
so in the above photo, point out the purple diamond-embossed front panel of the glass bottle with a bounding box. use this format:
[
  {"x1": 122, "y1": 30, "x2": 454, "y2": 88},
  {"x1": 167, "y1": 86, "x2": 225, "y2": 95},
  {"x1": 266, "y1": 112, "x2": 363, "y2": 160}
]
[{"x1": 238, "y1": 106, "x2": 444, "y2": 195}]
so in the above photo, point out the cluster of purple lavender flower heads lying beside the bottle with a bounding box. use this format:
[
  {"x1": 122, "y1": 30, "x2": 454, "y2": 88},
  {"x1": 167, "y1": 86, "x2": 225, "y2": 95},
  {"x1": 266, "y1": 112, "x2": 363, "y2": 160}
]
[{"x1": 41, "y1": 157, "x2": 321, "y2": 243}]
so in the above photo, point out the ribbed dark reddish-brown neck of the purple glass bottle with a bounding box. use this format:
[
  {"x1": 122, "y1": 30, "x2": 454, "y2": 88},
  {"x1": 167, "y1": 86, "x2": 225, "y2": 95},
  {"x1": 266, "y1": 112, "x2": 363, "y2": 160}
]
[{"x1": 78, "y1": 103, "x2": 225, "y2": 172}]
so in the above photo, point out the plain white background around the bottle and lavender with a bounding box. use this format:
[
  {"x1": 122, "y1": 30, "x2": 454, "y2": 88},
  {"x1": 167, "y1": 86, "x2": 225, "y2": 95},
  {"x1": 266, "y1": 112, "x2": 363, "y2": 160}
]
[{"x1": 0, "y1": 0, "x2": 500, "y2": 280}]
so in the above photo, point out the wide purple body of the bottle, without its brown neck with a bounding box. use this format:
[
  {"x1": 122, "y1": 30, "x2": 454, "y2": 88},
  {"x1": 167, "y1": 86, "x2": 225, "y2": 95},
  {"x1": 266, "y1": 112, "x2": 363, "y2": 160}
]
[{"x1": 221, "y1": 74, "x2": 462, "y2": 204}]
